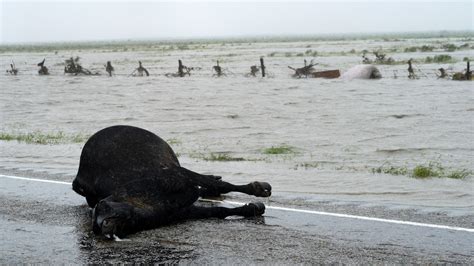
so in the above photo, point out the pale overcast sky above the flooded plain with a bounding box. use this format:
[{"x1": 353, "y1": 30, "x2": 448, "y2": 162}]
[{"x1": 0, "y1": 0, "x2": 474, "y2": 44}]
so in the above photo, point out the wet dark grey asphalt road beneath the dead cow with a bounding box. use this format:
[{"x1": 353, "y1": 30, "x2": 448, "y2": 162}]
[{"x1": 0, "y1": 173, "x2": 474, "y2": 265}]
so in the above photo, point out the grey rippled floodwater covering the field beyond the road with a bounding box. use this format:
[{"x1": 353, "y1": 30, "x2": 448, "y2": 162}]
[{"x1": 0, "y1": 35, "x2": 474, "y2": 215}]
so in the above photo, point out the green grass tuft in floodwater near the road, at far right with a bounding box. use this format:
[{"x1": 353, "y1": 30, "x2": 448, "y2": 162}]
[{"x1": 372, "y1": 162, "x2": 473, "y2": 179}]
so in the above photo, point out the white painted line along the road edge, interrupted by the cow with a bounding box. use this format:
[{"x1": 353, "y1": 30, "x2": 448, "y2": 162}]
[{"x1": 0, "y1": 174, "x2": 474, "y2": 233}]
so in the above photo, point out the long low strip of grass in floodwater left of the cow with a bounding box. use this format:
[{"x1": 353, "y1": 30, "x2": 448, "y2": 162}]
[{"x1": 0, "y1": 131, "x2": 88, "y2": 145}]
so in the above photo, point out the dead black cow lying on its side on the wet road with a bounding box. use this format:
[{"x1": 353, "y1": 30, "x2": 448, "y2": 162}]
[{"x1": 72, "y1": 126, "x2": 271, "y2": 238}]
